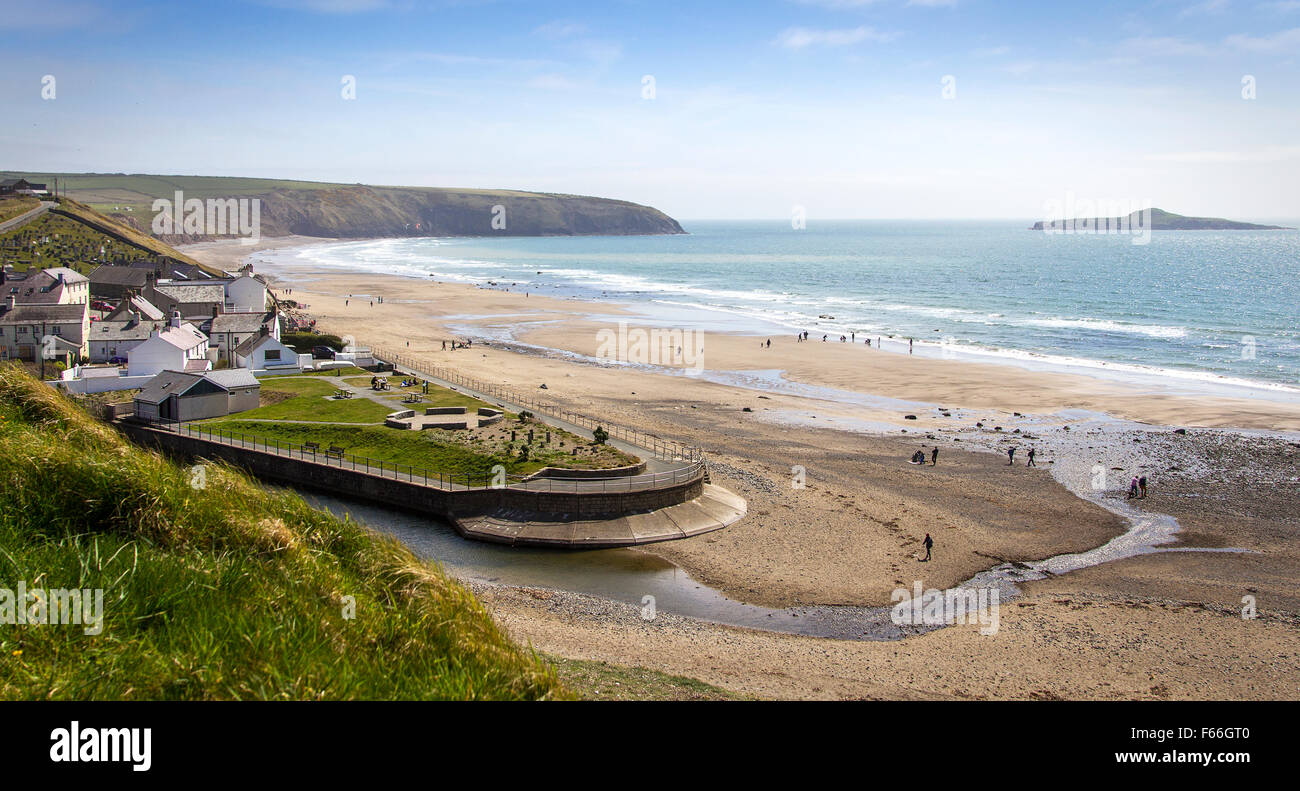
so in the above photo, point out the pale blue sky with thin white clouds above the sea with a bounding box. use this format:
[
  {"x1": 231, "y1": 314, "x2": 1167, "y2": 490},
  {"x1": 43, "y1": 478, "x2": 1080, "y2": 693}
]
[{"x1": 0, "y1": 0, "x2": 1300, "y2": 224}]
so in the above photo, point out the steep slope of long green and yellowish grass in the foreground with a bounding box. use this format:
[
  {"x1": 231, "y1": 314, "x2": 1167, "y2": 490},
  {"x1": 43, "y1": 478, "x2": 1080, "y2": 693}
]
[{"x1": 0, "y1": 366, "x2": 571, "y2": 700}]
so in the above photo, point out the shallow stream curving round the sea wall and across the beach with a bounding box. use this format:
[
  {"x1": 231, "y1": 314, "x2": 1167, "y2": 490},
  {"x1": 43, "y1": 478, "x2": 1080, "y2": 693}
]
[{"x1": 297, "y1": 400, "x2": 1235, "y2": 640}]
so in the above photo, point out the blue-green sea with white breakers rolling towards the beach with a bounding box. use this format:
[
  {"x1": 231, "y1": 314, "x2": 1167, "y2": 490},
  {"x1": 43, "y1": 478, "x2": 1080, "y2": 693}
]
[{"x1": 252, "y1": 220, "x2": 1300, "y2": 401}]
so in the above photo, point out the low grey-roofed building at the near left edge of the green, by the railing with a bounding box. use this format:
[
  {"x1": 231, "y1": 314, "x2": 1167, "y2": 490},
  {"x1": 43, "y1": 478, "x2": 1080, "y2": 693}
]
[{"x1": 134, "y1": 368, "x2": 261, "y2": 420}]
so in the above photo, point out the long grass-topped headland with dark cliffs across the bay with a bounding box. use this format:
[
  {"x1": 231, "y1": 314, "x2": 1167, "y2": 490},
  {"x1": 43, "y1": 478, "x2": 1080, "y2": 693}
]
[{"x1": 0, "y1": 172, "x2": 684, "y2": 243}]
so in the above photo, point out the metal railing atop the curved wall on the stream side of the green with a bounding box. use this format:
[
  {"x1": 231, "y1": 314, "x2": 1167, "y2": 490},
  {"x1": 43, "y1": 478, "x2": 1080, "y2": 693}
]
[{"x1": 144, "y1": 420, "x2": 705, "y2": 494}]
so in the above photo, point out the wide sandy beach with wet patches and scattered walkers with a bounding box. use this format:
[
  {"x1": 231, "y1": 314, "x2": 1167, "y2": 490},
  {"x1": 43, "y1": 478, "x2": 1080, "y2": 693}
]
[{"x1": 185, "y1": 237, "x2": 1300, "y2": 699}]
